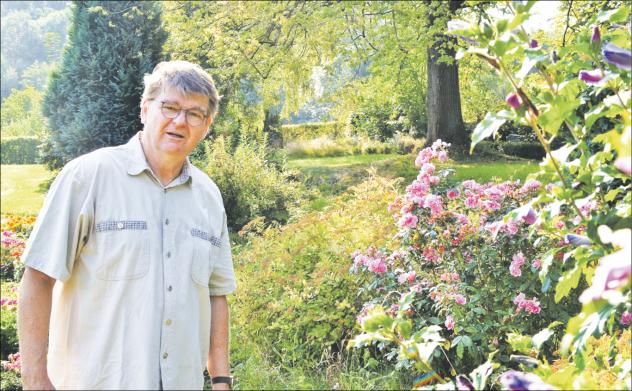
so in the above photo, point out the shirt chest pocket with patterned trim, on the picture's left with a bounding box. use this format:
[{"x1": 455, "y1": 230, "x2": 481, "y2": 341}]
[{"x1": 96, "y1": 220, "x2": 150, "y2": 281}]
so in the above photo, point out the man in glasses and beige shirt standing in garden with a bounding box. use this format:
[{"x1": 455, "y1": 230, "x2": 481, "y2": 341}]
[{"x1": 18, "y1": 61, "x2": 236, "y2": 390}]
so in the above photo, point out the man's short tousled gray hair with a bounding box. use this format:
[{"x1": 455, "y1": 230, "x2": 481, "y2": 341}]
[{"x1": 141, "y1": 60, "x2": 221, "y2": 118}]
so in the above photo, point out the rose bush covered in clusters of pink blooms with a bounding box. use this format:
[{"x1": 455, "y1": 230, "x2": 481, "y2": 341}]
[{"x1": 352, "y1": 141, "x2": 578, "y2": 376}]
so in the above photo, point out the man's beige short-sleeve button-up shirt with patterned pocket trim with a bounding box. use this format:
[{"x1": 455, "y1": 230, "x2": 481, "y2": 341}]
[{"x1": 23, "y1": 132, "x2": 236, "y2": 390}]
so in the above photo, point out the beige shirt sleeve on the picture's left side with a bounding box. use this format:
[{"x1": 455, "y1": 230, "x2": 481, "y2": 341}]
[{"x1": 22, "y1": 160, "x2": 93, "y2": 282}]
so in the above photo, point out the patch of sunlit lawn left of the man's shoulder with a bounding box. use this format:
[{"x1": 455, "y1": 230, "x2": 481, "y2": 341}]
[{"x1": 0, "y1": 164, "x2": 53, "y2": 214}]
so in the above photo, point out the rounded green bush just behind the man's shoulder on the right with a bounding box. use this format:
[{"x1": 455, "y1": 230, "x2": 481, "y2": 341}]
[{"x1": 202, "y1": 136, "x2": 300, "y2": 231}]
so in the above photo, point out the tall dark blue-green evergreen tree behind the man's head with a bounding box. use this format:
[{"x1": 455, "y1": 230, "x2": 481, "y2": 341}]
[{"x1": 43, "y1": 1, "x2": 166, "y2": 168}]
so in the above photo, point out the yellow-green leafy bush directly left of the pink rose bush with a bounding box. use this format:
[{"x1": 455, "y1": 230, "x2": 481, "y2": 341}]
[{"x1": 231, "y1": 178, "x2": 395, "y2": 366}]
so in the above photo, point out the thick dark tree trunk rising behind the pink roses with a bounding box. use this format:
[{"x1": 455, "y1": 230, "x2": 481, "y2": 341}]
[{"x1": 426, "y1": 1, "x2": 468, "y2": 146}]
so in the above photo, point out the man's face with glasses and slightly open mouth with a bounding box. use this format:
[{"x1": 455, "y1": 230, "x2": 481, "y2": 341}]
[{"x1": 141, "y1": 88, "x2": 213, "y2": 160}]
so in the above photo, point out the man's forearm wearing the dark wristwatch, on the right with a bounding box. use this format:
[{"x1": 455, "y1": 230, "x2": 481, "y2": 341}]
[{"x1": 206, "y1": 296, "x2": 230, "y2": 390}]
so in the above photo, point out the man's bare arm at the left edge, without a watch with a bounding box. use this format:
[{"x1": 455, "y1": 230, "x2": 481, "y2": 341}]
[{"x1": 18, "y1": 266, "x2": 55, "y2": 390}]
